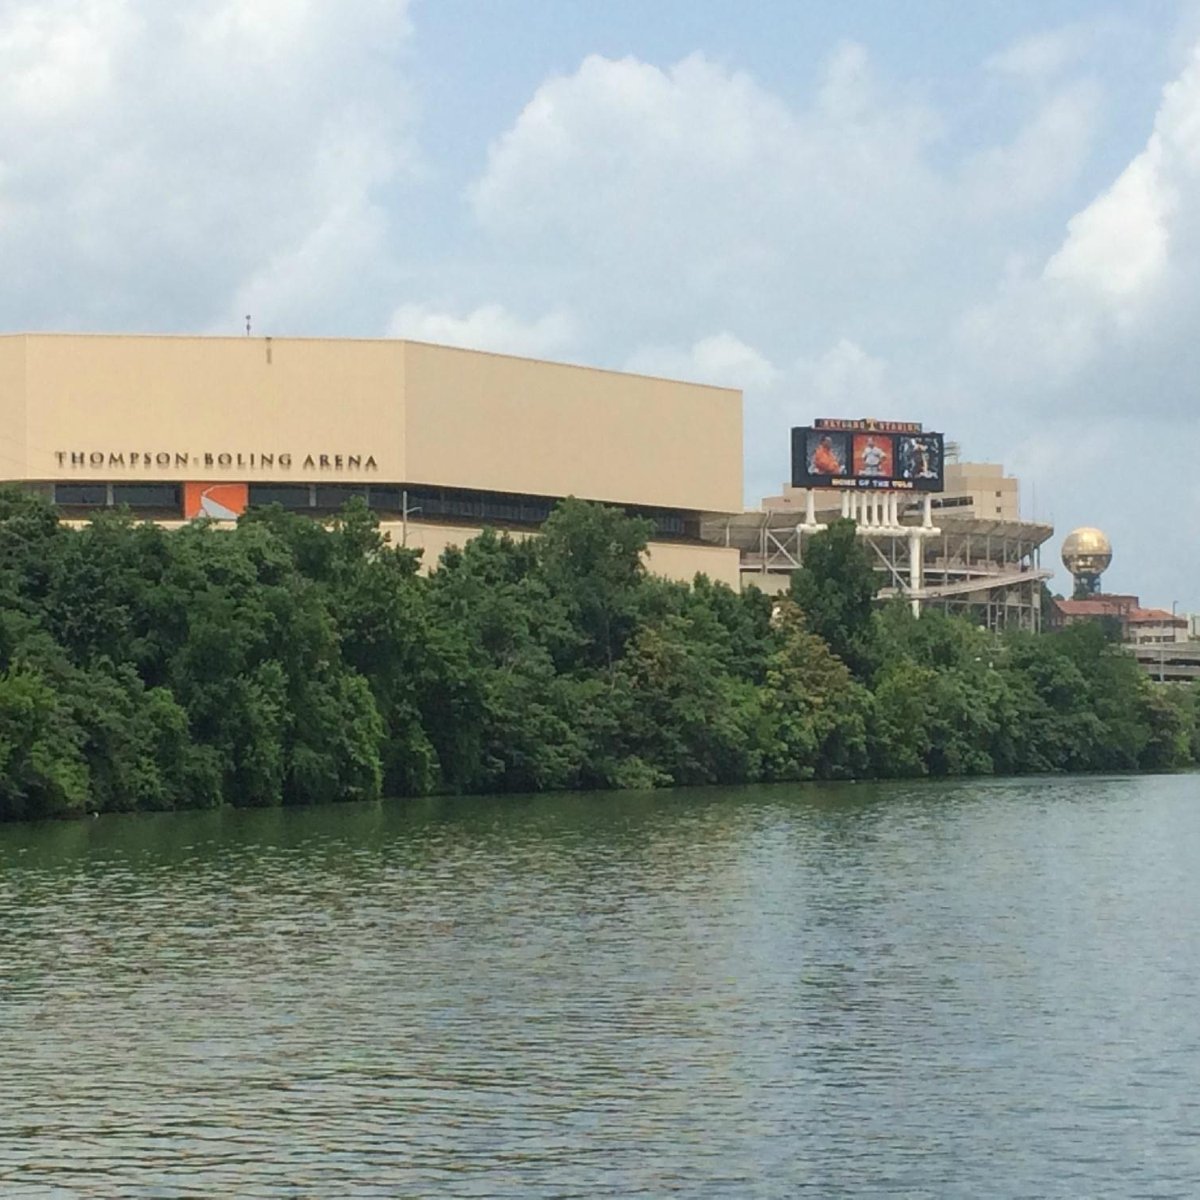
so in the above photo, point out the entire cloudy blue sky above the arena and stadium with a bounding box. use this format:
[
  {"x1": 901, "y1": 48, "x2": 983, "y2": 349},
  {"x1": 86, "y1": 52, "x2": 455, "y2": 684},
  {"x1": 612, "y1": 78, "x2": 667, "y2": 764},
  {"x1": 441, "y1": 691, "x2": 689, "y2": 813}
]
[{"x1": 0, "y1": 0, "x2": 1200, "y2": 600}]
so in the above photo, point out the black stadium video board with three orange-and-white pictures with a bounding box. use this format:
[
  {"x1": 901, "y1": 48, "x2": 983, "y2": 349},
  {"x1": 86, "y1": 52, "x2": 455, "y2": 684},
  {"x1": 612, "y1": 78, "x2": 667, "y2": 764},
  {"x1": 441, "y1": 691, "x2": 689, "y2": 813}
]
[{"x1": 792, "y1": 418, "x2": 946, "y2": 492}]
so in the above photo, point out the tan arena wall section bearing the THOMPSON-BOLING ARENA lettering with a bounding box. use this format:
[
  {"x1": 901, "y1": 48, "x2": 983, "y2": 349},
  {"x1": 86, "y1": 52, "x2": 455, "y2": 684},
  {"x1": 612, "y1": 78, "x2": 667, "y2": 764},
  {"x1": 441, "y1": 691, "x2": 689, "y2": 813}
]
[{"x1": 18, "y1": 335, "x2": 406, "y2": 482}]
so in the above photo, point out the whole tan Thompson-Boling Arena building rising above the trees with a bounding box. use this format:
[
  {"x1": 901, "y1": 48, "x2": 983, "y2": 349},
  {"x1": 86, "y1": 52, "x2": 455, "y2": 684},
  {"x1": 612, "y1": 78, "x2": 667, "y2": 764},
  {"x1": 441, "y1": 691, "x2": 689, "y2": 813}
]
[{"x1": 0, "y1": 334, "x2": 742, "y2": 586}]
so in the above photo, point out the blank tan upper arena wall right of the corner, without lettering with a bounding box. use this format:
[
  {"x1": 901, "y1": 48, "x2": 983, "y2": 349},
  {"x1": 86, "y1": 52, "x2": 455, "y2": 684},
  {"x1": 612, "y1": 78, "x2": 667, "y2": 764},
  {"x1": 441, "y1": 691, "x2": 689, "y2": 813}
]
[{"x1": 404, "y1": 342, "x2": 742, "y2": 512}]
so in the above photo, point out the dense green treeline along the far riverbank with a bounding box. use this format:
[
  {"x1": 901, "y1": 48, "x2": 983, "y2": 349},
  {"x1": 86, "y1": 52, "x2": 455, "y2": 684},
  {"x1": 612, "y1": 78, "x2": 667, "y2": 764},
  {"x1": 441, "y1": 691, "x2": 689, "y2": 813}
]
[{"x1": 0, "y1": 490, "x2": 1200, "y2": 818}]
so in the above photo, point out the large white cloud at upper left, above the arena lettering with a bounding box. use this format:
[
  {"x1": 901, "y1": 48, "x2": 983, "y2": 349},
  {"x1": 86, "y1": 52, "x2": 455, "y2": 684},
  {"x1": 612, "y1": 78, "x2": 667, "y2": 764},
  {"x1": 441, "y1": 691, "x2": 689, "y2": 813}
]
[{"x1": 0, "y1": 0, "x2": 416, "y2": 332}]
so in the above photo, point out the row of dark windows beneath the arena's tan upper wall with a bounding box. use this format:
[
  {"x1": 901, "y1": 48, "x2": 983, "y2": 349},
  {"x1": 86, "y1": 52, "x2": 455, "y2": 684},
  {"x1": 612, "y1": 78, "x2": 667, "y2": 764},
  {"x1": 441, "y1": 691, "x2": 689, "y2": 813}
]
[{"x1": 54, "y1": 484, "x2": 700, "y2": 538}]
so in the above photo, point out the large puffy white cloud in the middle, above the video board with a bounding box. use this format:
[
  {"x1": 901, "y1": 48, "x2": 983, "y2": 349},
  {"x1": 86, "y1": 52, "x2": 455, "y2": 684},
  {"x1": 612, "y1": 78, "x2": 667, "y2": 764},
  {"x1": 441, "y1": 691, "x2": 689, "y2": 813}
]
[{"x1": 469, "y1": 47, "x2": 943, "y2": 342}]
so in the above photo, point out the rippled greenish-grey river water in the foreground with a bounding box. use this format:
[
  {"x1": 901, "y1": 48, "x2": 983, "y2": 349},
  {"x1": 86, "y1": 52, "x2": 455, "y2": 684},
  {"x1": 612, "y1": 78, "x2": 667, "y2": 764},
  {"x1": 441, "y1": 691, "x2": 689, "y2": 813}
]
[{"x1": 0, "y1": 775, "x2": 1200, "y2": 1198}]
